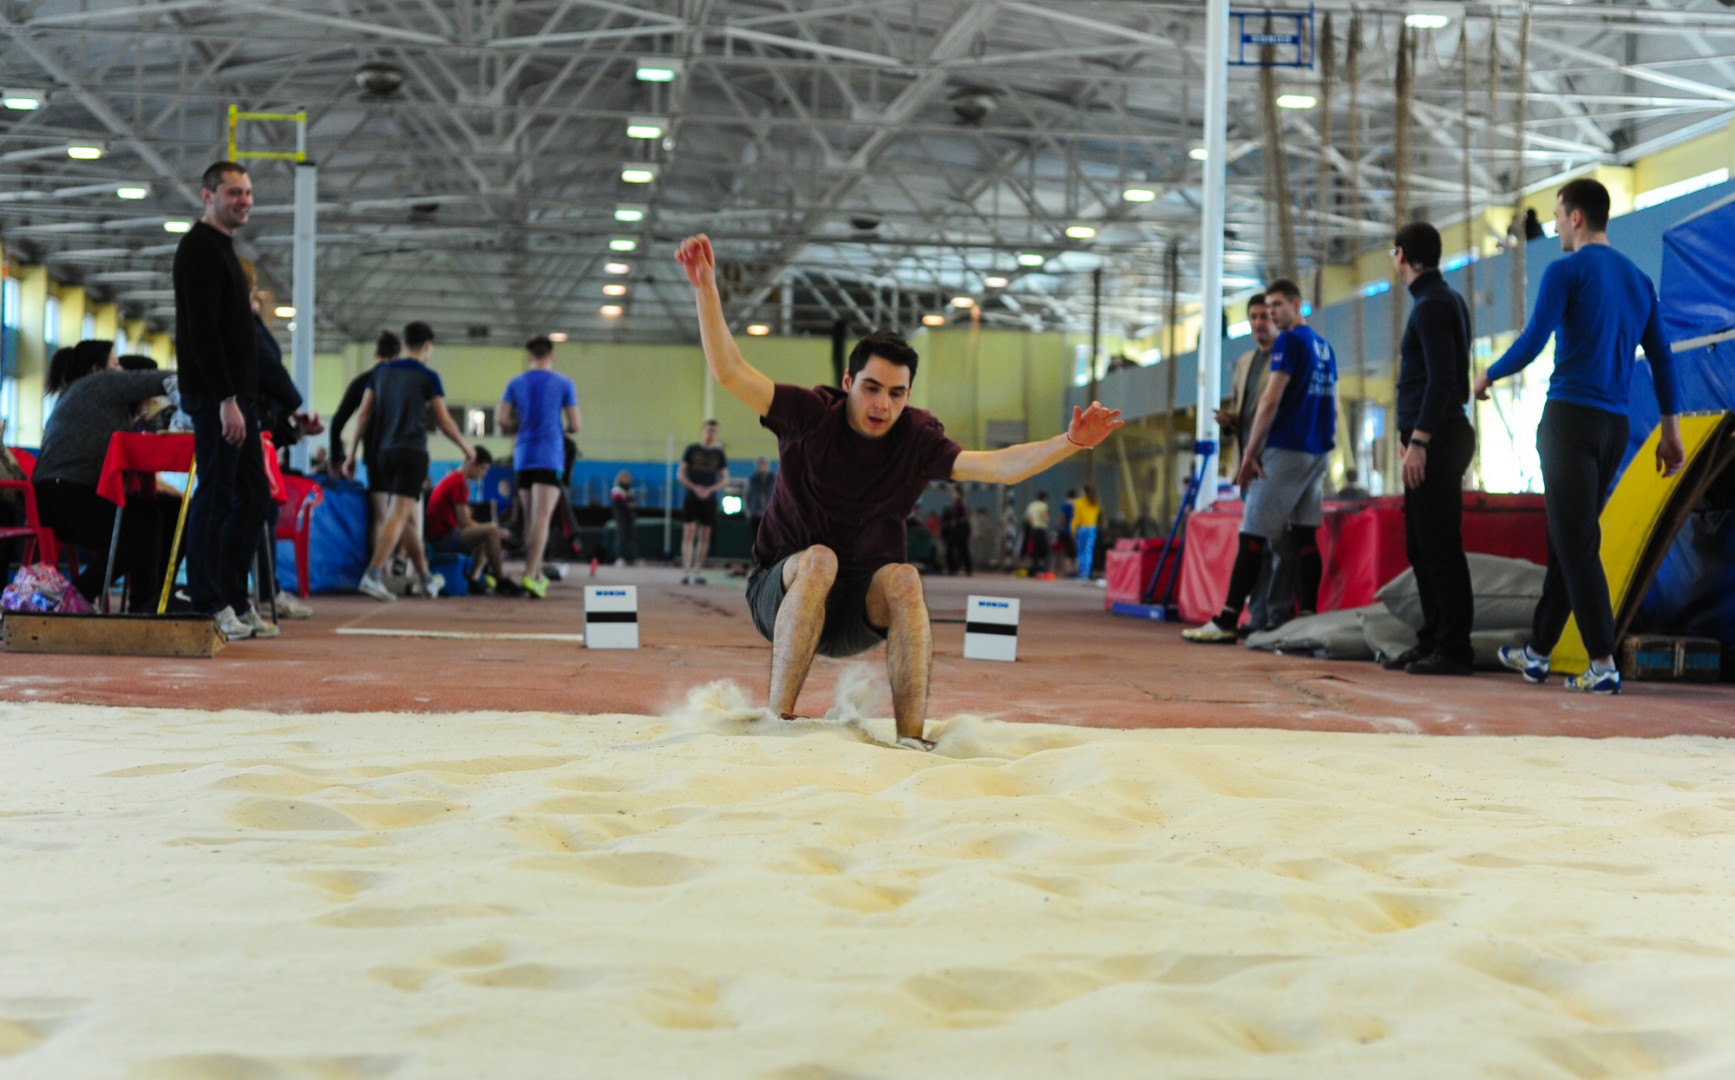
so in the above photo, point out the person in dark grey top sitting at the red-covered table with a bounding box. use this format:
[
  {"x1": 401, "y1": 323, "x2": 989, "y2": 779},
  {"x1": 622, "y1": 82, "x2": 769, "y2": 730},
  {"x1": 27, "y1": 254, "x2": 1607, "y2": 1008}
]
[{"x1": 31, "y1": 340, "x2": 175, "y2": 613}]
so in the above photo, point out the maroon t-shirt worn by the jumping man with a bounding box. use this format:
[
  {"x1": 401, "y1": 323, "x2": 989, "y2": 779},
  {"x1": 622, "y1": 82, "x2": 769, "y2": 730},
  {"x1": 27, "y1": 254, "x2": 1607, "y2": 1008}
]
[{"x1": 753, "y1": 382, "x2": 963, "y2": 571}]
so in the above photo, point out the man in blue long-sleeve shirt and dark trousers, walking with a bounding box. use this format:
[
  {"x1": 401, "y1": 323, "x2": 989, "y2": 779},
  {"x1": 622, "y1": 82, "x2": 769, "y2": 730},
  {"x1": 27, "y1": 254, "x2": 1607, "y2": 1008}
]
[{"x1": 1475, "y1": 179, "x2": 1686, "y2": 695}]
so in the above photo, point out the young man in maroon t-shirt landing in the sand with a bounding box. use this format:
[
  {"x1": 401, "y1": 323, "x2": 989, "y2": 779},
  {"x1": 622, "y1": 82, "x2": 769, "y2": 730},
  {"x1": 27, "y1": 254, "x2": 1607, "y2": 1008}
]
[{"x1": 675, "y1": 236, "x2": 1121, "y2": 750}]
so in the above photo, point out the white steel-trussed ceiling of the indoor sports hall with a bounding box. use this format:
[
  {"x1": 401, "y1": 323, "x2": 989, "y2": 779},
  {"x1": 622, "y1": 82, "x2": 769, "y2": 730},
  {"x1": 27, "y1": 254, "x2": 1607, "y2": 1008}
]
[{"x1": 0, "y1": 0, "x2": 1735, "y2": 347}]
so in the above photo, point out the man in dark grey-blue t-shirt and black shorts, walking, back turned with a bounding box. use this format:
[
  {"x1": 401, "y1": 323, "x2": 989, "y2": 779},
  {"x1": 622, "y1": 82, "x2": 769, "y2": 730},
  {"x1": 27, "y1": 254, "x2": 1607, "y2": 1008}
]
[{"x1": 344, "y1": 323, "x2": 475, "y2": 603}]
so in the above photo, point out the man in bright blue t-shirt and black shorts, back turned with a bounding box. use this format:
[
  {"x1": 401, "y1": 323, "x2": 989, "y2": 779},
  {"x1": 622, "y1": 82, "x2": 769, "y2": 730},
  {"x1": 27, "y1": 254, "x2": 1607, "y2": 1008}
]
[{"x1": 494, "y1": 335, "x2": 583, "y2": 599}]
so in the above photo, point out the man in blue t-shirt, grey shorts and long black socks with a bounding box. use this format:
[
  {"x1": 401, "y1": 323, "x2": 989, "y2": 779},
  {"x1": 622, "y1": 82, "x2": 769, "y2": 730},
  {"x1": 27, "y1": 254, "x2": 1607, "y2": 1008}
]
[{"x1": 1182, "y1": 278, "x2": 1338, "y2": 642}]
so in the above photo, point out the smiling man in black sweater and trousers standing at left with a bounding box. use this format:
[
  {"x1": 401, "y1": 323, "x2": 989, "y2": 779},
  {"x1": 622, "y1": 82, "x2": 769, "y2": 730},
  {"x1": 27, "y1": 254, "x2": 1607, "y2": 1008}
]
[{"x1": 175, "y1": 161, "x2": 278, "y2": 641}]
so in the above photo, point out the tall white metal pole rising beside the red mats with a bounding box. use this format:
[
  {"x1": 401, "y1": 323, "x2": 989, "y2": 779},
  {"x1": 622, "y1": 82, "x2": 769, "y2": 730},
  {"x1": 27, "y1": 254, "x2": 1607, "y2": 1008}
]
[{"x1": 1194, "y1": 0, "x2": 1228, "y2": 507}]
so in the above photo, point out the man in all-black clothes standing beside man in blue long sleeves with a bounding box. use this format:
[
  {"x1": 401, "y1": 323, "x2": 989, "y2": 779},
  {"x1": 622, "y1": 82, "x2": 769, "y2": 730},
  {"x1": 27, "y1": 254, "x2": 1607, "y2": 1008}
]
[{"x1": 1386, "y1": 222, "x2": 1476, "y2": 675}]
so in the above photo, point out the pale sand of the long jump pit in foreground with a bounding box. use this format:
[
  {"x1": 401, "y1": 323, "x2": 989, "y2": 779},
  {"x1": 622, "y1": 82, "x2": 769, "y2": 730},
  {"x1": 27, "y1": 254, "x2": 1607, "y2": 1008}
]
[{"x1": 0, "y1": 688, "x2": 1735, "y2": 1080}]
